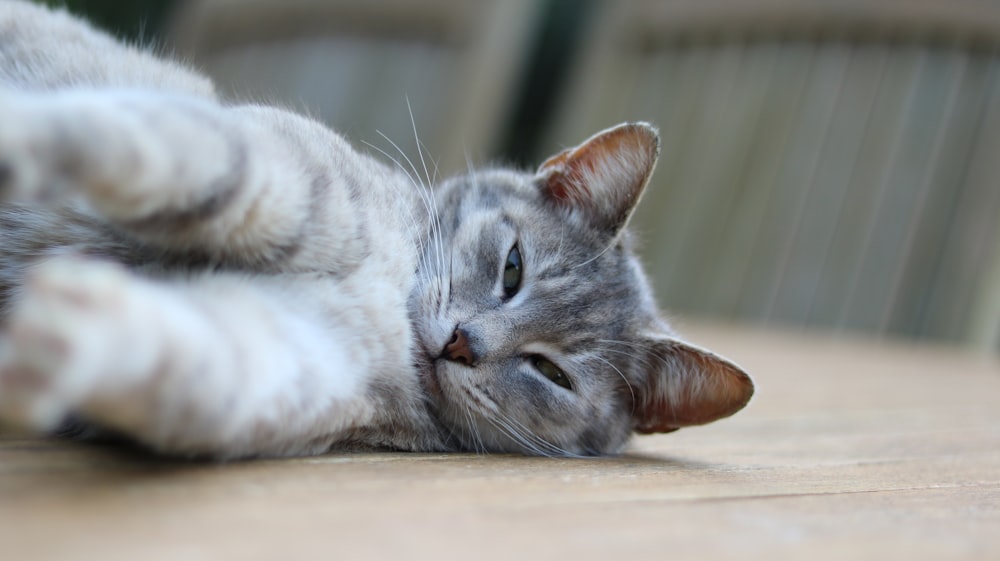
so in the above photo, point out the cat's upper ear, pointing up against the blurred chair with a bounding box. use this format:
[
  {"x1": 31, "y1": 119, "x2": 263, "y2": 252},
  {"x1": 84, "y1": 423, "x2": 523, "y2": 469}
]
[{"x1": 537, "y1": 123, "x2": 660, "y2": 235}]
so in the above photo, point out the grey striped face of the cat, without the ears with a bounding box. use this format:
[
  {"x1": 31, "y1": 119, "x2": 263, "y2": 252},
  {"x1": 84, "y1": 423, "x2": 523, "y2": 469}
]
[{"x1": 412, "y1": 168, "x2": 639, "y2": 454}]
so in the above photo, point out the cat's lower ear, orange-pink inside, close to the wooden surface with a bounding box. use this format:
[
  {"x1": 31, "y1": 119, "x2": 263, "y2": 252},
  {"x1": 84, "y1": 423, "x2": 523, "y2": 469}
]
[{"x1": 632, "y1": 336, "x2": 754, "y2": 434}]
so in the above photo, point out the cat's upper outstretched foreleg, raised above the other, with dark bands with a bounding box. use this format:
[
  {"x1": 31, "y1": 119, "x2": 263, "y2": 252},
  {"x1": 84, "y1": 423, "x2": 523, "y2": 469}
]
[{"x1": 0, "y1": 90, "x2": 384, "y2": 270}]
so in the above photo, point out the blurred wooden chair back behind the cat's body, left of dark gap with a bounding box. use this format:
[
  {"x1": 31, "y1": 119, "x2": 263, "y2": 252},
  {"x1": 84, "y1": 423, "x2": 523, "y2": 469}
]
[{"x1": 168, "y1": 0, "x2": 539, "y2": 176}]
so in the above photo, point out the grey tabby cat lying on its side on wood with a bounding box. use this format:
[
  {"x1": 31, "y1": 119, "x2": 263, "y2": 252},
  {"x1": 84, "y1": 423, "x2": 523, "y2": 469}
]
[{"x1": 0, "y1": 1, "x2": 753, "y2": 458}]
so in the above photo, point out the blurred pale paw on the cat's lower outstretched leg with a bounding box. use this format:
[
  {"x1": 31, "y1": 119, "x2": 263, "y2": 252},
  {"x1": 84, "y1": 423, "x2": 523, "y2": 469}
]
[{"x1": 0, "y1": 258, "x2": 153, "y2": 430}]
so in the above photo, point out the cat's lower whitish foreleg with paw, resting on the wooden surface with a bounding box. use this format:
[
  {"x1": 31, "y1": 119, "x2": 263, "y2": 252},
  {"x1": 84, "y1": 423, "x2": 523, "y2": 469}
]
[{"x1": 0, "y1": 258, "x2": 370, "y2": 458}]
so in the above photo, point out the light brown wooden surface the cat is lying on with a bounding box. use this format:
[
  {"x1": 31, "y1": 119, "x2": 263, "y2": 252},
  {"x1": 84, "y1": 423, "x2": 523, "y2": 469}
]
[{"x1": 0, "y1": 326, "x2": 1000, "y2": 561}]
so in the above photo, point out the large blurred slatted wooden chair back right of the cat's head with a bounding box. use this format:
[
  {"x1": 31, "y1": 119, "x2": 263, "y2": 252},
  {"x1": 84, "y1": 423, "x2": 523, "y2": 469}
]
[{"x1": 547, "y1": 0, "x2": 1000, "y2": 348}]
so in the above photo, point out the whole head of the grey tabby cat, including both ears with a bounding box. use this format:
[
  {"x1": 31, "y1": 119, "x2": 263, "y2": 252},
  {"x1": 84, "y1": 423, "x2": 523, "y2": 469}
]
[{"x1": 410, "y1": 123, "x2": 753, "y2": 455}]
